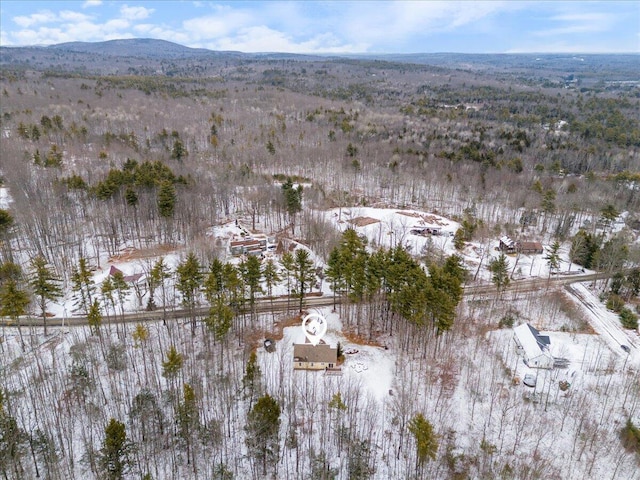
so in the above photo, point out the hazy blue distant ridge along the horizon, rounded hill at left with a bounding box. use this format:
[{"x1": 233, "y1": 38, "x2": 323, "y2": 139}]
[{"x1": 0, "y1": 38, "x2": 640, "y2": 83}]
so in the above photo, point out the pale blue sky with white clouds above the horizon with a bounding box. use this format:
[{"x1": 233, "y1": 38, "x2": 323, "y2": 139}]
[{"x1": 0, "y1": 0, "x2": 640, "y2": 54}]
